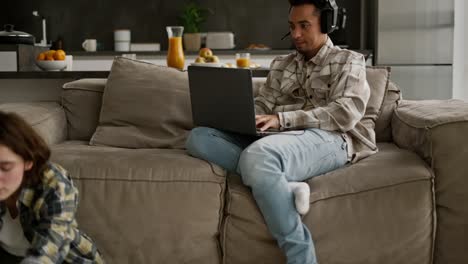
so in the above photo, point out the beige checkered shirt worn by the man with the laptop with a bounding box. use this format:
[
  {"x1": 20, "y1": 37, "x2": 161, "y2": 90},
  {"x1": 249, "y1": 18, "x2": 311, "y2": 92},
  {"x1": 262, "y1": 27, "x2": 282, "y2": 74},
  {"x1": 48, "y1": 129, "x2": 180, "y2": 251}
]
[{"x1": 255, "y1": 39, "x2": 377, "y2": 162}]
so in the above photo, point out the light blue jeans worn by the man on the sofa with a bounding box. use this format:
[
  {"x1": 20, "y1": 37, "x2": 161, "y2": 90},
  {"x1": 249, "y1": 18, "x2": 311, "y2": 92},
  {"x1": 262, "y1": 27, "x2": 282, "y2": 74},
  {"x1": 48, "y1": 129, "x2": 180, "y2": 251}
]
[{"x1": 186, "y1": 127, "x2": 347, "y2": 264}]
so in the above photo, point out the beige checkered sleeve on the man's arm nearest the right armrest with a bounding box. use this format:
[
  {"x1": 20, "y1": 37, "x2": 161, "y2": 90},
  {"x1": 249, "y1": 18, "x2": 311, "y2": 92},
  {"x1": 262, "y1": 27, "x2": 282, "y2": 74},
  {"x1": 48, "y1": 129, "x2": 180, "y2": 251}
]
[{"x1": 278, "y1": 56, "x2": 370, "y2": 132}]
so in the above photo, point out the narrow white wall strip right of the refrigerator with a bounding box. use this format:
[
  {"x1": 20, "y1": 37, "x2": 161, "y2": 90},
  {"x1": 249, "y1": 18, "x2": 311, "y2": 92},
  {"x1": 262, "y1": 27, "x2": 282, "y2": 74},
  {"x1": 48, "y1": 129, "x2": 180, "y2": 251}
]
[{"x1": 452, "y1": 0, "x2": 468, "y2": 101}]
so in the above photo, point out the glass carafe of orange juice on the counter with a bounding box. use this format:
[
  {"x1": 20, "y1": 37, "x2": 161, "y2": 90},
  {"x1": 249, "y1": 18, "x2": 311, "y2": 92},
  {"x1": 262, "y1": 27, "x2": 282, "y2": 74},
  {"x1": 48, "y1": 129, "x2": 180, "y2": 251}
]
[{"x1": 166, "y1": 26, "x2": 185, "y2": 70}]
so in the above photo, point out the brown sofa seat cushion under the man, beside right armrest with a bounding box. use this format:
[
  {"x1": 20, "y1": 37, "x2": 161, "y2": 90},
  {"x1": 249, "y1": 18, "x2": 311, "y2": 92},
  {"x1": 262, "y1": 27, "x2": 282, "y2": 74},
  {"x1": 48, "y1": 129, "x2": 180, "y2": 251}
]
[{"x1": 222, "y1": 143, "x2": 435, "y2": 264}]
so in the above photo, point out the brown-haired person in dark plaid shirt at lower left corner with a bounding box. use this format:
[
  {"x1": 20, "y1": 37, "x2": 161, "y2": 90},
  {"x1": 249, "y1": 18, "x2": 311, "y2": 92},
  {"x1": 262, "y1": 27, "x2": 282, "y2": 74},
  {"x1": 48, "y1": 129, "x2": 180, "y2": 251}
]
[{"x1": 0, "y1": 111, "x2": 104, "y2": 264}]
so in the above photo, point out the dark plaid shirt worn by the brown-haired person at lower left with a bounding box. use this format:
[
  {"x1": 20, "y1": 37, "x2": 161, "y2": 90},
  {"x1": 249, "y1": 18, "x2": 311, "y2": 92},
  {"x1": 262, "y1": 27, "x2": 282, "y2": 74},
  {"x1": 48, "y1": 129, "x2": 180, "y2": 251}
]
[{"x1": 0, "y1": 163, "x2": 104, "y2": 264}]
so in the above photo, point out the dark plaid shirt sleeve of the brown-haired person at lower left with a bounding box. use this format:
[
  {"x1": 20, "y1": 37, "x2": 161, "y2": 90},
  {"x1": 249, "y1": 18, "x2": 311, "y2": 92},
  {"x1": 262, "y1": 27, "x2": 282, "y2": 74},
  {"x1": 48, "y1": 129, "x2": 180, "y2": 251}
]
[{"x1": 21, "y1": 167, "x2": 78, "y2": 264}]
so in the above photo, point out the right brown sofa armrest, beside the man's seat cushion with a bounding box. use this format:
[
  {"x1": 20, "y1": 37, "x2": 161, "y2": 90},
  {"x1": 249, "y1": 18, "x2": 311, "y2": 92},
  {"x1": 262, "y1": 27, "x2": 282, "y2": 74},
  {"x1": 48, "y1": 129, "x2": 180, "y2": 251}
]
[{"x1": 392, "y1": 100, "x2": 468, "y2": 263}]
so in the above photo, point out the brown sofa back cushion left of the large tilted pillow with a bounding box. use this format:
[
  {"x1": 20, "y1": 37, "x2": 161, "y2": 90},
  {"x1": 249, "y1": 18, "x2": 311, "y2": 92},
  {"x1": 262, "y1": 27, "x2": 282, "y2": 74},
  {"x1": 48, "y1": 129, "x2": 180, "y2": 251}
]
[{"x1": 62, "y1": 79, "x2": 107, "y2": 141}]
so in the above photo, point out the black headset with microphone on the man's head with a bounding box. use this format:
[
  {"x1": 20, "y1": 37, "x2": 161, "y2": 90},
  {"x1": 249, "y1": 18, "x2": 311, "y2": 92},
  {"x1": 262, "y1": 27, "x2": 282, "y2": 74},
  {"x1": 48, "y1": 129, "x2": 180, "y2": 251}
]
[{"x1": 281, "y1": 0, "x2": 338, "y2": 39}]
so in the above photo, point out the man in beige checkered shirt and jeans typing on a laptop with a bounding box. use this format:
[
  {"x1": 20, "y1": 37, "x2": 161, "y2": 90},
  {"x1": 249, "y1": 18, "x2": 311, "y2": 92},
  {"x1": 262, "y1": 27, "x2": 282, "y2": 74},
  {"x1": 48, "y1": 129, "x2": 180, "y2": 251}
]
[{"x1": 186, "y1": 0, "x2": 377, "y2": 264}]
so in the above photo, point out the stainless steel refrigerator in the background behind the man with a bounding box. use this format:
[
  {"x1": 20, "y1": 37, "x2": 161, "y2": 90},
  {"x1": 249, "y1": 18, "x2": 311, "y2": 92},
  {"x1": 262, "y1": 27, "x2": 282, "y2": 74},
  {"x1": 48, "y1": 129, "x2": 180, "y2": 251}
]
[{"x1": 371, "y1": 0, "x2": 454, "y2": 100}]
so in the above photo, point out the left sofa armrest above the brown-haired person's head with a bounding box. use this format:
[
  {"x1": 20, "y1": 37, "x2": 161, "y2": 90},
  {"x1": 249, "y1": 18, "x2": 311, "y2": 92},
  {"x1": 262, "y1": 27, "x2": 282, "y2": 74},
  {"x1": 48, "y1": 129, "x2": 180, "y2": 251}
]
[{"x1": 0, "y1": 102, "x2": 67, "y2": 145}]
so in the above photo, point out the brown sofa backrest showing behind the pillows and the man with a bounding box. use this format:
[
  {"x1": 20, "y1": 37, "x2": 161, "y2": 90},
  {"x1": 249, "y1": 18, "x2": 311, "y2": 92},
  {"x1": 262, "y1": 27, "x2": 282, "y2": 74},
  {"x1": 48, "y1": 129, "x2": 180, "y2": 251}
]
[{"x1": 62, "y1": 74, "x2": 400, "y2": 142}]
